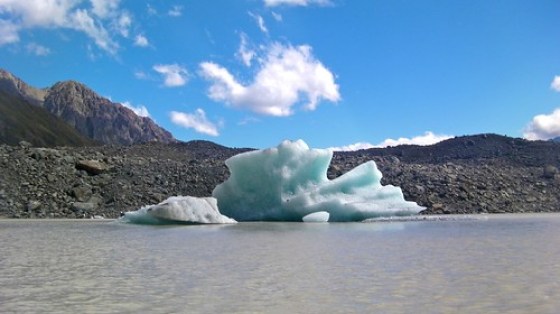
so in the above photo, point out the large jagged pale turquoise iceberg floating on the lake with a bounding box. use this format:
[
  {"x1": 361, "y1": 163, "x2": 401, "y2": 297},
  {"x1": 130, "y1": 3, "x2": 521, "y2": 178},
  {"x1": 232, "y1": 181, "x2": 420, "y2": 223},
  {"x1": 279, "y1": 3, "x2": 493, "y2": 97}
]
[{"x1": 212, "y1": 140, "x2": 423, "y2": 221}]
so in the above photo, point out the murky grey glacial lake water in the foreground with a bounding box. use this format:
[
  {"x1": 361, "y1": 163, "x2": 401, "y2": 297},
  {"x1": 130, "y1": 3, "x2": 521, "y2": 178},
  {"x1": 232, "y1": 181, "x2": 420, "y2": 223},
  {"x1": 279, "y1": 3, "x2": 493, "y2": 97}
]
[{"x1": 0, "y1": 214, "x2": 560, "y2": 313}]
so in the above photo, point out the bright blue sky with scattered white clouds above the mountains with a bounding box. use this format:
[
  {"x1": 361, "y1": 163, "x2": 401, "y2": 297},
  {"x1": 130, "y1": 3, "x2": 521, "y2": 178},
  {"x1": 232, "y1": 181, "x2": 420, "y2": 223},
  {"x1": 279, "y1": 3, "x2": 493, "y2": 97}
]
[{"x1": 0, "y1": 0, "x2": 560, "y2": 148}]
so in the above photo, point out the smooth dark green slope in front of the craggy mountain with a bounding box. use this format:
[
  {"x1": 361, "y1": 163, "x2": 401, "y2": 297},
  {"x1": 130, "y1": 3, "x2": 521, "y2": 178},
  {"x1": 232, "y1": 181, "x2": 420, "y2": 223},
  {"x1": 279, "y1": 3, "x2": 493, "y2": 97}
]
[{"x1": 0, "y1": 91, "x2": 96, "y2": 147}]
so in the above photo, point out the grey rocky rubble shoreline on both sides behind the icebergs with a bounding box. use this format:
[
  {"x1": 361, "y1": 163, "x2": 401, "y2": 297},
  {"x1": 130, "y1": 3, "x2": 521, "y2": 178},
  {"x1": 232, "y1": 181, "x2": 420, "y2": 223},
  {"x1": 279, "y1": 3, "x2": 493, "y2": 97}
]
[{"x1": 0, "y1": 135, "x2": 560, "y2": 218}]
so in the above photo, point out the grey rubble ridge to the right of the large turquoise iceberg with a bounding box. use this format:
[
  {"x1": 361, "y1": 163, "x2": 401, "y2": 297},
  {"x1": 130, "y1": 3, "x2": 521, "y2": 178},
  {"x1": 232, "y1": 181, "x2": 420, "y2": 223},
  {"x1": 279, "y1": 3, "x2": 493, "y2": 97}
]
[{"x1": 332, "y1": 134, "x2": 560, "y2": 214}]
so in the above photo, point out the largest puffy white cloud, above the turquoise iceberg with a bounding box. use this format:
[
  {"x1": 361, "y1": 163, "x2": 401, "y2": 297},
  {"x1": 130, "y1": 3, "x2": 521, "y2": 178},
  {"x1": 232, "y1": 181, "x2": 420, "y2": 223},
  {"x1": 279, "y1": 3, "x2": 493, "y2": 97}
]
[{"x1": 200, "y1": 43, "x2": 340, "y2": 117}]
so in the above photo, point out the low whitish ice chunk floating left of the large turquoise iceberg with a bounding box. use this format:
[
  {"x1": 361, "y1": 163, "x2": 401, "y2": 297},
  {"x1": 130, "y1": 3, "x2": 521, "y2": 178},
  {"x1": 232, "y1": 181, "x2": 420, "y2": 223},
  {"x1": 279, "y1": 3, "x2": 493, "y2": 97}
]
[{"x1": 121, "y1": 196, "x2": 236, "y2": 224}]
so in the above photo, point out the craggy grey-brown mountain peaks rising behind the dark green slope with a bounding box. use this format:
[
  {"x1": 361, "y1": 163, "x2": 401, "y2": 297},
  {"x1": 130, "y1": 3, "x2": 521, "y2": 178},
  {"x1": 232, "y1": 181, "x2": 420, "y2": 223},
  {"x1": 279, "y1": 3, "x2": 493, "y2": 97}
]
[{"x1": 0, "y1": 69, "x2": 176, "y2": 145}]
